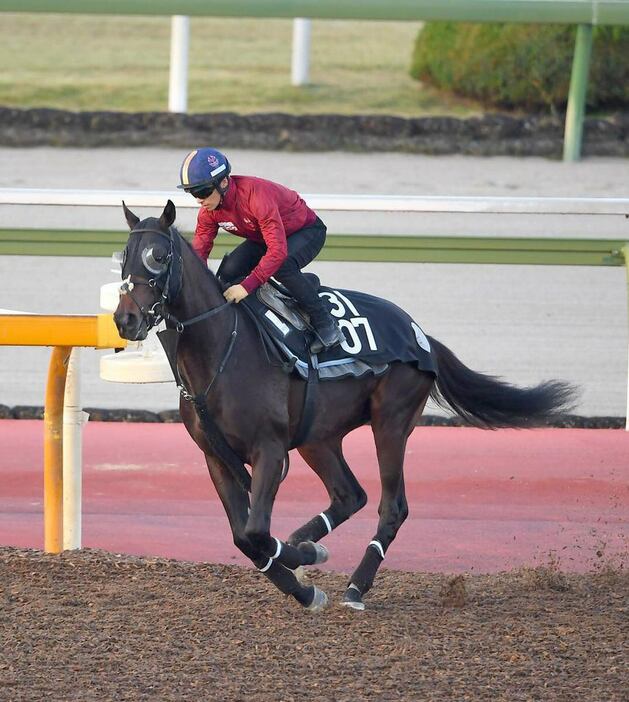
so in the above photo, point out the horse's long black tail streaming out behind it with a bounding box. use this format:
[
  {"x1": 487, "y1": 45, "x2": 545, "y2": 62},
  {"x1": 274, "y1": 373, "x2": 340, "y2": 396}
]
[{"x1": 428, "y1": 337, "x2": 577, "y2": 429}]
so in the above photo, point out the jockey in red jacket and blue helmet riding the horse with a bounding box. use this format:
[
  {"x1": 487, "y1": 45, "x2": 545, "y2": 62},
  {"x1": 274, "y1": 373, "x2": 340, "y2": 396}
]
[{"x1": 178, "y1": 148, "x2": 344, "y2": 348}]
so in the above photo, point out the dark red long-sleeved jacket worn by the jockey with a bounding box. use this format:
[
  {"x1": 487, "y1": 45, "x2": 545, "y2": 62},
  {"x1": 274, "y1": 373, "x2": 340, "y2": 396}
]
[{"x1": 192, "y1": 176, "x2": 317, "y2": 293}]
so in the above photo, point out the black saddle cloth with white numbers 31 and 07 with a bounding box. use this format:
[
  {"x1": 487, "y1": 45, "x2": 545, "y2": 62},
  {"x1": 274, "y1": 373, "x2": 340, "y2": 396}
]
[{"x1": 241, "y1": 280, "x2": 437, "y2": 380}]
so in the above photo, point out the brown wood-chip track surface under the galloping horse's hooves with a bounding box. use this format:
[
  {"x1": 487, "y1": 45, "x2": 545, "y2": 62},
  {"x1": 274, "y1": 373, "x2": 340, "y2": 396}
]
[{"x1": 0, "y1": 548, "x2": 629, "y2": 702}]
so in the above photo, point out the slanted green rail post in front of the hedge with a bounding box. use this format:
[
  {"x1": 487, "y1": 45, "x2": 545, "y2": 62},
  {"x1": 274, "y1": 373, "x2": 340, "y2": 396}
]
[{"x1": 563, "y1": 24, "x2": 592, "y2": 161}]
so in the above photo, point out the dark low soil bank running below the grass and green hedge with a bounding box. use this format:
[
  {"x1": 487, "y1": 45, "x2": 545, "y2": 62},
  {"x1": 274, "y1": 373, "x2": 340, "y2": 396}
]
[{"x1": 0, "y1": 107, "x2": 629, "y2": 158}]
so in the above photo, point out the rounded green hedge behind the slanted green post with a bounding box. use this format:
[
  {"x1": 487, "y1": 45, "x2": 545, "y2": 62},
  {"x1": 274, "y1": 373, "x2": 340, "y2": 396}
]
[{"x1": 411, "y1": 22, "x2": 629, "y2": 111}]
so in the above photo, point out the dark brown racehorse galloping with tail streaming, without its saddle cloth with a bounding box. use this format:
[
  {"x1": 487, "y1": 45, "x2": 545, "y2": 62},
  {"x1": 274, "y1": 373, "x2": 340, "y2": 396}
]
[{"x1": 114, "y1": 200, "x2": 575, "y2": 611}]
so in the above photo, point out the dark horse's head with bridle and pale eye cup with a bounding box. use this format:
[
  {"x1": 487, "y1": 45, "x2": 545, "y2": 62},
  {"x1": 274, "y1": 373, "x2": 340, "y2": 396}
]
[{"x1": 114, "y1": 200, "x2": 182, "y2": 341}]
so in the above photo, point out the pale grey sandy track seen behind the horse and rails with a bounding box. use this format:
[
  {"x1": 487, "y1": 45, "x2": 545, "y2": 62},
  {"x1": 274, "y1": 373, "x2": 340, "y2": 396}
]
[{"x1": 0, "y1": 148, "x2": 629, "y2": 416}]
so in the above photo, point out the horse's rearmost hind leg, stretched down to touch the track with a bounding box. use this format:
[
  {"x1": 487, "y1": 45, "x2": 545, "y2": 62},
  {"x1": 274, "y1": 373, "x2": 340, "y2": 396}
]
[{"x1": 343, "y1": 365, "x2": 433, "y2": 609}]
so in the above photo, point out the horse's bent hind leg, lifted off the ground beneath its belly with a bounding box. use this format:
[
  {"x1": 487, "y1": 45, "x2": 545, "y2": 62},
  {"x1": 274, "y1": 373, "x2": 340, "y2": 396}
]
[{"x1": 288, "y1": 436, "x2": 367, "y2": 546}]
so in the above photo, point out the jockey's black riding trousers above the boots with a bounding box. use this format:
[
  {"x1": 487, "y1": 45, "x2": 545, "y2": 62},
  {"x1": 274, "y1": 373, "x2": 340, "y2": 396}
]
[{"x1": 221, "y1": 217, "x2": 327, "y2": 315}]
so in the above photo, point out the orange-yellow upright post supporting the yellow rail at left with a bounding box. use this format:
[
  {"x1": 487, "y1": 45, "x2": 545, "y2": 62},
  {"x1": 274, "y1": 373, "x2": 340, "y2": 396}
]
[{"x1": 44, "y1": 346, "x2": 72, "y2": 553}]
